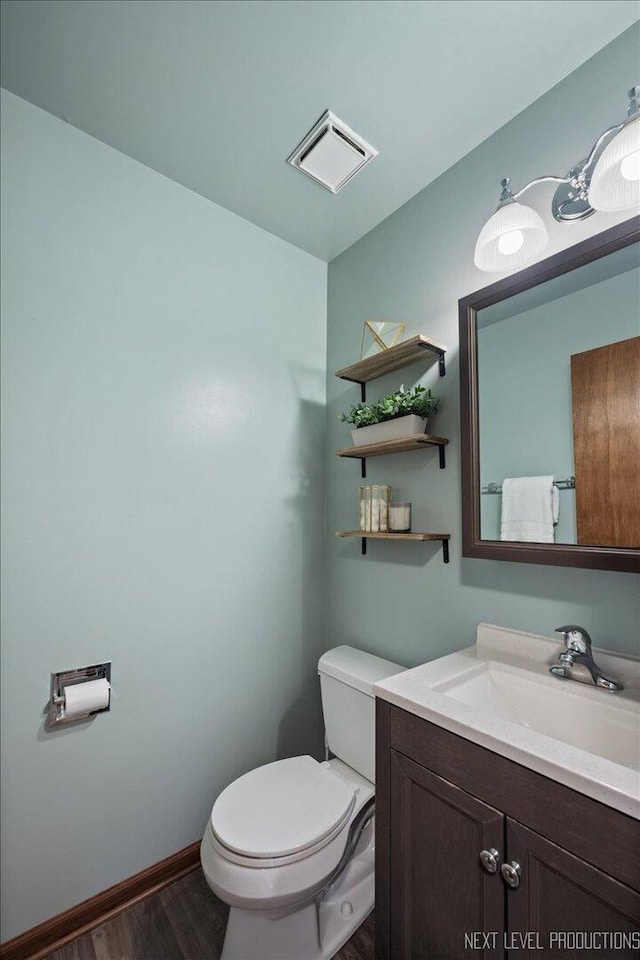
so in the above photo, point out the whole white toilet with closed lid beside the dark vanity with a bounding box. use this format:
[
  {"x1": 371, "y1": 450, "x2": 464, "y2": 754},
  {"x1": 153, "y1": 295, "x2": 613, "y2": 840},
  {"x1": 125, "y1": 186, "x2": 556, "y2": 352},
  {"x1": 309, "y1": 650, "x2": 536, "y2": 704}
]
[{"x1": 200, "y1": 646, "x2": 404, "y2": 960}]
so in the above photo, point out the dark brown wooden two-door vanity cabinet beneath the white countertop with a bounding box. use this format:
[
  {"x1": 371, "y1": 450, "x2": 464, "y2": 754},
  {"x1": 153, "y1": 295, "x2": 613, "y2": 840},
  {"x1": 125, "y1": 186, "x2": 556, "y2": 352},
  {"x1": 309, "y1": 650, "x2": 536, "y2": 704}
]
[{"x1": 376, "y1": 700, "x2": 640, "y2": 960}]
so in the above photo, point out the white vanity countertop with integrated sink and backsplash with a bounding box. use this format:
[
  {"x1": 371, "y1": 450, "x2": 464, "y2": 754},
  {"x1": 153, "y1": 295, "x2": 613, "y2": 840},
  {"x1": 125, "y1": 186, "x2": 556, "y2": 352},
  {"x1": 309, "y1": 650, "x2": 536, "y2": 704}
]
[{"x1": 375, "y1": 624, "x2": 640, "y2": 820}]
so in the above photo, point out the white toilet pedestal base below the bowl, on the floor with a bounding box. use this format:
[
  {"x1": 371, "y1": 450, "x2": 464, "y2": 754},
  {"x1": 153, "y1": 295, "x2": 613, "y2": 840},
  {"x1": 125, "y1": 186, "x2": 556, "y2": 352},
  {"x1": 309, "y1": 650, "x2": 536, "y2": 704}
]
[{"x1": 220, "y1": 822, "x2": 374, "y2": 960}]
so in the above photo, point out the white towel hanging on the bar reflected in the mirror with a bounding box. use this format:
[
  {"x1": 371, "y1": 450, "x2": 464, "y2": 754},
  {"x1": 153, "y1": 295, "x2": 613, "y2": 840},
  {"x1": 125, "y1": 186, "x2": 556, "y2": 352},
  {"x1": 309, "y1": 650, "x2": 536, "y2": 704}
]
[{"x1": 500, "y1": 477, "x2": 560, "y2": 543}]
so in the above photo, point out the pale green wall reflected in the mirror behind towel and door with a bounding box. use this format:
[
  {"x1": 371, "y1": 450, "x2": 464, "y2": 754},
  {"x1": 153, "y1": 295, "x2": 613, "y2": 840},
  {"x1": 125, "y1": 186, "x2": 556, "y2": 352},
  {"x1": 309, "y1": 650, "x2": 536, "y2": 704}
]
[{"x1": 478, "y1": 266, "x2": 640, "y2": 543}]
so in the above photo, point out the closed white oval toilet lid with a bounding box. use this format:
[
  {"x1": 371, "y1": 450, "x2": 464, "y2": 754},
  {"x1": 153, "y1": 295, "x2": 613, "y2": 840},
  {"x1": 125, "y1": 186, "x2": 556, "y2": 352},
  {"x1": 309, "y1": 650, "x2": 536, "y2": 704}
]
[{"x1": 211, "y1": 757, "x2": 355, "y2": 857}]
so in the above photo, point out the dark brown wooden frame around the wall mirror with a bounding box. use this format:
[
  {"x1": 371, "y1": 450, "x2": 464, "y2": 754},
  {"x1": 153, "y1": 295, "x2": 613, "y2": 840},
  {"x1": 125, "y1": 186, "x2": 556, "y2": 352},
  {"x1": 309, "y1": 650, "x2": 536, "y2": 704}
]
[{"x1": 459, "y1": 217, "x2": 640, "y2": 573}]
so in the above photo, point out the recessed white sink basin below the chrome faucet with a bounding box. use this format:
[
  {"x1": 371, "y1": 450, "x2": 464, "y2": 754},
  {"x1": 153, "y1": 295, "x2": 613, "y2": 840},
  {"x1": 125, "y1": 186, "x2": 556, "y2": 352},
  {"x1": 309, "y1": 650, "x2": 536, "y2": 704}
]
[{"x1": 432, "y1": 661, "x2": 640, "y2": 769}]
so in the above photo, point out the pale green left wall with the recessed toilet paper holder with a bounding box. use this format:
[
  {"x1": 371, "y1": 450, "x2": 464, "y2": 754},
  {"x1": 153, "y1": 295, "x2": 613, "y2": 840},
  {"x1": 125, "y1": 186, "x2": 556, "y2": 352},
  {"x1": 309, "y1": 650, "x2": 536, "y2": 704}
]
[{"x1": 2, "y1": 88, "x2": 326, "y2": 940}]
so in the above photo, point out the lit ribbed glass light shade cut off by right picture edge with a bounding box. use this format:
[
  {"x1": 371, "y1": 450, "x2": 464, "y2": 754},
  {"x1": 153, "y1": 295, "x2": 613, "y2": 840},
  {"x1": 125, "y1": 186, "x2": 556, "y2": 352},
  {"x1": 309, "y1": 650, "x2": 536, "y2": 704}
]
[{"x1": 589, "y1": 117, "x2": 640, "y2": 211}]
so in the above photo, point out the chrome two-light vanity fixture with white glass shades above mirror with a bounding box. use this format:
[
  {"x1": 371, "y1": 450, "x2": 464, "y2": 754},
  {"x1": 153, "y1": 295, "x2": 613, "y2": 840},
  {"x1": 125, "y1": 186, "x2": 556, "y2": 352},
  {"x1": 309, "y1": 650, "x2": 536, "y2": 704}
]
[{"x1": 474, "y1": 86, "x2": 640, "y2": 273}]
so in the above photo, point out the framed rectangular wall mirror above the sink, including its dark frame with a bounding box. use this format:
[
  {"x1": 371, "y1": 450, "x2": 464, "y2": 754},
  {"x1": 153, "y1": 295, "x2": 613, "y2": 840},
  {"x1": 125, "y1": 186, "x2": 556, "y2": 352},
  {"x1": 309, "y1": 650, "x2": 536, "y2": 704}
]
[{"x1": 459, "y1": 218, "x2": 640, "y2": 572}]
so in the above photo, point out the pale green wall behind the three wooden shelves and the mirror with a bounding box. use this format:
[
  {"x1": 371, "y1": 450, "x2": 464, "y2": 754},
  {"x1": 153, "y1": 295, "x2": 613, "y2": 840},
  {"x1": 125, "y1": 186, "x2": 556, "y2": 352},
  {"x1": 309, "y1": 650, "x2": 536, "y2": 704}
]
[{"x1": 327, "y1": 29, "x2": 640, "y2": 665}]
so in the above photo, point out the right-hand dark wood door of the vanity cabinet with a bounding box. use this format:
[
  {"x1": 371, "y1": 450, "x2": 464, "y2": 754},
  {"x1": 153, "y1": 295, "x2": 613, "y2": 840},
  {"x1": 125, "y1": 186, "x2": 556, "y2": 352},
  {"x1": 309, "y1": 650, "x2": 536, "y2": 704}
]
[{"x1": 505, "y1": 819, "x2": 640, "y2": 960}]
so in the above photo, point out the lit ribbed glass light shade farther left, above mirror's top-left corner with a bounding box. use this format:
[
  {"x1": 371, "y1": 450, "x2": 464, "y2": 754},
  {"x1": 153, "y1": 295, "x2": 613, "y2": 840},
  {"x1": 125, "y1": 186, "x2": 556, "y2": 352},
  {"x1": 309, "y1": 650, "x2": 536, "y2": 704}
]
[{"x1": 474, "y1": 201, "x2": 548, "y2": 273}]
